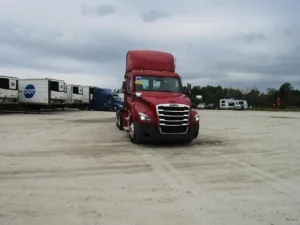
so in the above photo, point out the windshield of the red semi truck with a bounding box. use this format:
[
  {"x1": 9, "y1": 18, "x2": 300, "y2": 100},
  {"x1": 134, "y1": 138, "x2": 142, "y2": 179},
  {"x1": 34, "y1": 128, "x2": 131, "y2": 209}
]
[{"x1": 134, "y1": 75, "x2": 183, "y2": 93}]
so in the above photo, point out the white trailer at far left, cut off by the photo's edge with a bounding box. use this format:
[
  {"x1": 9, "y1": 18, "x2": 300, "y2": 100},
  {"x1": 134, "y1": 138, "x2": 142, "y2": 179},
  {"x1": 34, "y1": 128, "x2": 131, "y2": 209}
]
[{"x1": 0, "y1": 75, "x2": 18, "y2": 109}]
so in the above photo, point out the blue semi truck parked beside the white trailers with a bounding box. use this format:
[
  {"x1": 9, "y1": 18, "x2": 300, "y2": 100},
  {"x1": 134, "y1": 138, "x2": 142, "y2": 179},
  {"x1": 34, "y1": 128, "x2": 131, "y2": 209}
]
[{"x1": 91, "y1": 87, "x2": 124, "y2": 112}]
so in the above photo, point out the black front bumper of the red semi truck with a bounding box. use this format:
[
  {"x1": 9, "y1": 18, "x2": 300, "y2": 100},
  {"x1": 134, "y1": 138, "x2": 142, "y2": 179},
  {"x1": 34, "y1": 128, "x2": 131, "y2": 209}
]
[{"x1": 135, "y1": 123, "x2": 199, "y2": 141}]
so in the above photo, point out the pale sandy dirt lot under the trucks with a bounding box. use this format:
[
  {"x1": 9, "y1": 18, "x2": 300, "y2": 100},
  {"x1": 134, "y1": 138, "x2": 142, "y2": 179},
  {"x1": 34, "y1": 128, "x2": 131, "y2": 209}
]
[{"x1": 0, "y1": 111, "x2": 300, "y2": 225}]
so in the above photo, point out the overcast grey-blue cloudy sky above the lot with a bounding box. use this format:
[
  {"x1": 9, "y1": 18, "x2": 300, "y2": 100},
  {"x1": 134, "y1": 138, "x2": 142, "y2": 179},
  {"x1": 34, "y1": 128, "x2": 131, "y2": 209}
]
[{"x1": 0, "y1": 0, "x2": 300, "y2": 90}]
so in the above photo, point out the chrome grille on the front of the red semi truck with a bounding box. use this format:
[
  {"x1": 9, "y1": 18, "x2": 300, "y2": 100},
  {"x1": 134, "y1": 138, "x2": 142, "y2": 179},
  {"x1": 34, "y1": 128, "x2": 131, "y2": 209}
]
[{"x1": 156, "y1": 104, "x2": 190, "y2": 126}]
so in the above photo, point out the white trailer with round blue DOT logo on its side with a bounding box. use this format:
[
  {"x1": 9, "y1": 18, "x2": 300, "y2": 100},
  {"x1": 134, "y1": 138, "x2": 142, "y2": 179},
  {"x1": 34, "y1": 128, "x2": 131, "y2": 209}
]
[{"x1": 18, "y1": 78, "x2": 65, "y2": 112}]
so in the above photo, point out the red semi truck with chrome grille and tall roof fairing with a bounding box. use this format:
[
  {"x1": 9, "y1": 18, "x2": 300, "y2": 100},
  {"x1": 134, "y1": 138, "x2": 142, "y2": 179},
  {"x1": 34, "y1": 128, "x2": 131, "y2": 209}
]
[{"x1": 116, "y1": 50, "x2": 200, "y2": 144}]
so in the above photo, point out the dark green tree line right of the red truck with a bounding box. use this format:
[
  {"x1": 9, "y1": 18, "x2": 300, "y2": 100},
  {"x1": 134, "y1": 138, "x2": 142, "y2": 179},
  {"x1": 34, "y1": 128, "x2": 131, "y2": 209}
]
[{"x1": 190, "y1": 82, "x2": 300, "y2": 109}]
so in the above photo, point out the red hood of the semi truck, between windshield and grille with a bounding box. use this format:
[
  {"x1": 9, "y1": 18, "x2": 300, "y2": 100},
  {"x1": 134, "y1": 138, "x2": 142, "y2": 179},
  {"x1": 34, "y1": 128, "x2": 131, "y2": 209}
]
[{"x1": 141, "y1": 91, "x2": 191, "y2": 106}]
